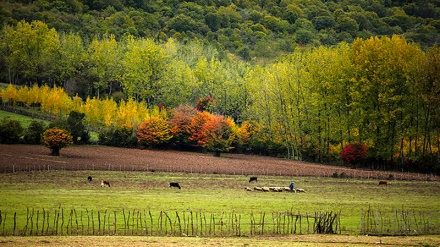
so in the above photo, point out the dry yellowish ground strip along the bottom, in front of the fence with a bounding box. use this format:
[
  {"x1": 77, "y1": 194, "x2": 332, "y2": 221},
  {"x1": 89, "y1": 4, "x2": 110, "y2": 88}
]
[{"x1": 0, "y1": 234, "x2": 440, "y2": 247}]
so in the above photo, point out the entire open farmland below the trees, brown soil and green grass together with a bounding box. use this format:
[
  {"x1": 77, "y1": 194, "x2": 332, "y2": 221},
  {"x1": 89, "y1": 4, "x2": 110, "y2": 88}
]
[{"x1": 0, "y1": 145, "x2": 440, "y2": 246}]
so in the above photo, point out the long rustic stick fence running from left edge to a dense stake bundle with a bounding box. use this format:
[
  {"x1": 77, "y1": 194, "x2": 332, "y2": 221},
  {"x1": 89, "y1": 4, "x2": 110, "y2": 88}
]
[{"x1": 0, "y1": 208, "x2": 340, "y2": 237}]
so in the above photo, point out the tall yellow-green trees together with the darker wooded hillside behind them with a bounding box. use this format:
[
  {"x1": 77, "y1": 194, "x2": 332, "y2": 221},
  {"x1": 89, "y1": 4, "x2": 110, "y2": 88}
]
[{"x1": 0, "y1": 0, "x2": 440, "y2": 173}]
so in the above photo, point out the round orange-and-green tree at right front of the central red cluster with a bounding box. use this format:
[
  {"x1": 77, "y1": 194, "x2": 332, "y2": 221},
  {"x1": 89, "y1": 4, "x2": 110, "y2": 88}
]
[{"x1": 198, "y1": 115, "x2": 235, "y2": 156}]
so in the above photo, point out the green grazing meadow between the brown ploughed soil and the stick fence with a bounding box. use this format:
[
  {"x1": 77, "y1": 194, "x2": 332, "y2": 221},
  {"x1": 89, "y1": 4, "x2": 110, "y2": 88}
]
[{"x1": 0, "y1": 171, "x2": 440, "y2": 234}]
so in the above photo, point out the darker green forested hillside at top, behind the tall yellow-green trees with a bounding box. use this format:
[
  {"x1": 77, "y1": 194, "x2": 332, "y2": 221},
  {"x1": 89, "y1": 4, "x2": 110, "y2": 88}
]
[{"x1": 0, "y1": 0, "x2": 440, "y2": 61}]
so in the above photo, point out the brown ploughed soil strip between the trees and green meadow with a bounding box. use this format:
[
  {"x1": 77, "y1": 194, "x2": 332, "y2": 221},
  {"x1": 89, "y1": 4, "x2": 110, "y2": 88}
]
[{"x1": 0, "y1": 144, "x2": 440, "y2": 181}]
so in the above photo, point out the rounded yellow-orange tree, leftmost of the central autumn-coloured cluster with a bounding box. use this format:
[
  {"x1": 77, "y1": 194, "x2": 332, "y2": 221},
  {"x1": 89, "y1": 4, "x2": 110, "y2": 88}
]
[{"x1": 136, "y1": 117, "x2": 173, "y2": 147}]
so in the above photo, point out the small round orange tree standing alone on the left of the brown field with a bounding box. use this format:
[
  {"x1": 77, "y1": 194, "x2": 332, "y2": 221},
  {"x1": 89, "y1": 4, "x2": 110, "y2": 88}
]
[{"x1": 43, "y1": 127, "x2": 73, "y2": 156}]
